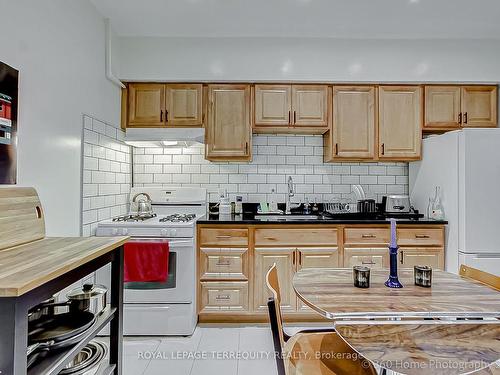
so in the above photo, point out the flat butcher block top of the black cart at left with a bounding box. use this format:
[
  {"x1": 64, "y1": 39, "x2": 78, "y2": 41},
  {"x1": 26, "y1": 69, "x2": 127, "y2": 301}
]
[{"x1": 0, "y1": 237, "x2": 129, "y2": 297}]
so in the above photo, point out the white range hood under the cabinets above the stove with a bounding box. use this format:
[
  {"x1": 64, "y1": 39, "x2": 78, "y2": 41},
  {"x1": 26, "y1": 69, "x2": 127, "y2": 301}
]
[{"x1": 124, "y1": 128, "x2": 205, "y2": 147}]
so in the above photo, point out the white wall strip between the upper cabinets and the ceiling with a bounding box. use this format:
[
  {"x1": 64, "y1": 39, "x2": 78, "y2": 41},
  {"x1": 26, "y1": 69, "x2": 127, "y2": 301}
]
[{"x1": 115, "y1": 37, "x2": 500, "y2": 83}]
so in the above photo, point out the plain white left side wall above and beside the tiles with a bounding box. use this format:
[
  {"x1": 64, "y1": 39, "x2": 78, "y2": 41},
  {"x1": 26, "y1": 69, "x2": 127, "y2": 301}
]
[{"x1": 0, "y1": 0, "x2": 120, "y2": 235}]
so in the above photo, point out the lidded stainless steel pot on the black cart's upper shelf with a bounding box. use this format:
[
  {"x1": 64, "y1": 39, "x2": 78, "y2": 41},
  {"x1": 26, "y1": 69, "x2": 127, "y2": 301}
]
[{"x1": 66, "y1": 284, "x2": 108, "y2": 316}]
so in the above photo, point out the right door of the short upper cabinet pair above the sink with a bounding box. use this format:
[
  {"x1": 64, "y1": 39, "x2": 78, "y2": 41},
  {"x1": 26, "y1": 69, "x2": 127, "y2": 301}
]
[{"x1": 292, "y1": 85, "x2": 329, "y2": 128}]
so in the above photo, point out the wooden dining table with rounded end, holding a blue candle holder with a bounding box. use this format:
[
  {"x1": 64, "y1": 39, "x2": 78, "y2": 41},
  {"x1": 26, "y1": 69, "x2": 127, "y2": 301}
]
[{"x1": 293, "y1": 268, "x2": 500, "y2": 375}]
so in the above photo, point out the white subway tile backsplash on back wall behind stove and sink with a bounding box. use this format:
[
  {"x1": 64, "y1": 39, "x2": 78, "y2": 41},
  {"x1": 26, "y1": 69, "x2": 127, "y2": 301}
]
[{"x1": 132, "y1": 135, "x2": 408, "y2": 202}]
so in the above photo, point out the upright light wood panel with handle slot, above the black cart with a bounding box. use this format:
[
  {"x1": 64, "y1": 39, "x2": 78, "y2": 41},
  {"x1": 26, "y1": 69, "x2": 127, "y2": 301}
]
[{"x1": 0, "y1": 187, "x2": 45, "y2": 250}]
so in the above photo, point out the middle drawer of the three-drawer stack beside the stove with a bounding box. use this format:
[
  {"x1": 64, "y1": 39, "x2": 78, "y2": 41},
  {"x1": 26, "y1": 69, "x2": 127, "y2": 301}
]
[{"x1": 200, "y1": 248, "x2": 248, "y2": 280}]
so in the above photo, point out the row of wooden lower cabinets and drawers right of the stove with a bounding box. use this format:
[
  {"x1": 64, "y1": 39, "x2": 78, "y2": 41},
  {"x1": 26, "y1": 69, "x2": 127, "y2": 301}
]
[{"x1": 197, "y1": 224, "x2": 445, "y2": 322}]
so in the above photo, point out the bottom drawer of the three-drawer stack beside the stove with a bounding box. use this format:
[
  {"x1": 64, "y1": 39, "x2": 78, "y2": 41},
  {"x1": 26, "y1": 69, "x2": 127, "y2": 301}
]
[{"x1": 200, "y1": 281, "x2": 248, "y2": 313}]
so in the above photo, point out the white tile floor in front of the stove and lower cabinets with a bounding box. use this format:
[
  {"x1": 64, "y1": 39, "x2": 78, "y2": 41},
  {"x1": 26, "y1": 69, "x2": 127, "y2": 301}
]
[{"x1": 106, "y1": 324, "x2": 328, "y2": 375}]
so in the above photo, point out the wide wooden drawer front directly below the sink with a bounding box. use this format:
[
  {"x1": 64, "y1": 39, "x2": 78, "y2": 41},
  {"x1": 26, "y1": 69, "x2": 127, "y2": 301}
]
[{"x1": 255, "y1": 228, "x2": 337, "y2": 247}]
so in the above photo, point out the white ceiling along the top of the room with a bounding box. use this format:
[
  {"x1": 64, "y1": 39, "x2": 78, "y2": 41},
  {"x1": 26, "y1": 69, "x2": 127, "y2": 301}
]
[{"x1": 90, "y1": 0, "x2": 500, "y2": 39}]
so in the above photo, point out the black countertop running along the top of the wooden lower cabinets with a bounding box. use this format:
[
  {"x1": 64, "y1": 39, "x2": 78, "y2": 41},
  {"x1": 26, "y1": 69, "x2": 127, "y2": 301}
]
[{"x1": 196, "y1": 214, "x2": 448, "y2": 225}]
